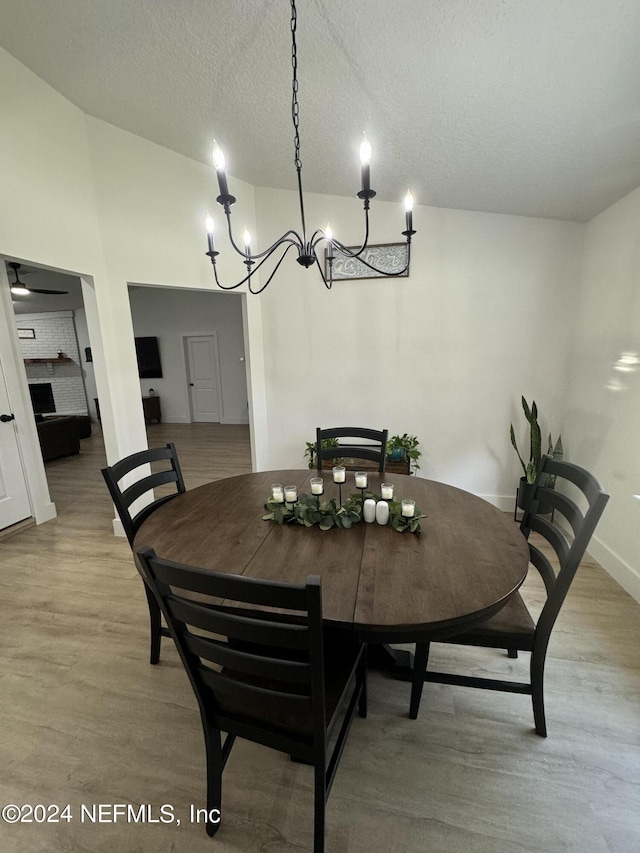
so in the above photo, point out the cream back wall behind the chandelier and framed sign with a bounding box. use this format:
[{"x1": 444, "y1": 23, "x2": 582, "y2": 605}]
[{"x1": 257, "y1": 189, "x2": 584, "y2": 500}]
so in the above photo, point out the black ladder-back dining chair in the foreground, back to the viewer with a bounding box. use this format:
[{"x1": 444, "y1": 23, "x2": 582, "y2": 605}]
[{"x1": 137, "y1": 548, "x2": 367, "y2": 853}]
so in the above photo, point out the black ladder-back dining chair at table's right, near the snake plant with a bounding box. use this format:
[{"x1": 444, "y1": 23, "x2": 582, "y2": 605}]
[{"x1": 409, "y1": 456, "x2": 609, "y2": 737}]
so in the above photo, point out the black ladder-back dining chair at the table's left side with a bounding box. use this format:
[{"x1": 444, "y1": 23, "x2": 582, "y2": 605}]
[{"x1": 102, "y1": 444, "x2": 186, "y2": 664}]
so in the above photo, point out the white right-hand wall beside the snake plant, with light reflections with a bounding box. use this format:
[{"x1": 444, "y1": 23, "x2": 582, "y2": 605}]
[{"x1": 565, "y1": 188, "x2": 640, "y2": 600}]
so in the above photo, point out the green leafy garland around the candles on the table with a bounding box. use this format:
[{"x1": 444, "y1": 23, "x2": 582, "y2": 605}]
[{"x1": 262, "y1": 492, "x2": 426, "y2": 536}]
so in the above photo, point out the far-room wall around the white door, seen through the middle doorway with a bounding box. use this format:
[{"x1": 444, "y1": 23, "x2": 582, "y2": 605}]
[{"x1": 129, "y1": 287, "x2": 249, "y2": 424}]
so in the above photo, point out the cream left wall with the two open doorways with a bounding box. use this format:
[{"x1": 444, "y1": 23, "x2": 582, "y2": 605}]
[{"x1": 0, "y1": 50, "x2": 268, "y2": 517}]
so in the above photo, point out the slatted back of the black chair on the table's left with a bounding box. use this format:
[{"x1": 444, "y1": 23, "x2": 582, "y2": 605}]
[{"x1": 102, "y1": 443, "x2": 186, "y2": 545}]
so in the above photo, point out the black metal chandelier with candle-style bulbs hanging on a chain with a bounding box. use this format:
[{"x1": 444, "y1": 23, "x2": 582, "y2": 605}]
[{"x1": 206, "y1": 0, "x2": 416, "y2": 293}]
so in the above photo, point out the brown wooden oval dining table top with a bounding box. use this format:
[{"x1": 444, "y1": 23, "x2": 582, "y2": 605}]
[{"x1": 134, "y1": 470, "x2": 529, "y2": 642}]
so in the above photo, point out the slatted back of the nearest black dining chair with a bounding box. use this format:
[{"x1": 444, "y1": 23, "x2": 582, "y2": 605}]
[{"x1": 137, "y1": 549, "x2": 325, "y2": 740}]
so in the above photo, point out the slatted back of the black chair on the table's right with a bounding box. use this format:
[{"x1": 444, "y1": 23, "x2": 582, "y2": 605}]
[{"x1": 521, "y1": 456, "x2": 609, "y2": 642}]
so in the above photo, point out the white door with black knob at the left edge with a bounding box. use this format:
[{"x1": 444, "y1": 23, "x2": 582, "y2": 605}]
[{"x1": 0, "y1": 364, "x2": 31, "y2": 530}]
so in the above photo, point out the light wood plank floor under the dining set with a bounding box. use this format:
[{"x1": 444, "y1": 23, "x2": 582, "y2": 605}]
[{"x1": 0, "y1": 424, "x2": 640, "y2": 853}]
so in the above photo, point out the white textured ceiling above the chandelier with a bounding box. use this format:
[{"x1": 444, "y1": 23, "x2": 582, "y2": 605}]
[{"x1": 0, "y1": 0, "x2": 640, "y2": 220}]
